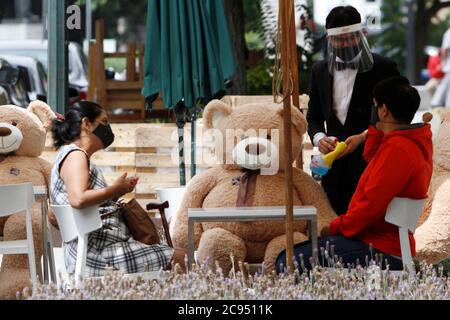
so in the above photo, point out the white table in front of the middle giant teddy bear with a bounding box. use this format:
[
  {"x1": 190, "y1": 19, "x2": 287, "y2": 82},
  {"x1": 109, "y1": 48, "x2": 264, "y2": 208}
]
[{"x1": 188, "y1": 206, "x2": 317, "y2": 268}]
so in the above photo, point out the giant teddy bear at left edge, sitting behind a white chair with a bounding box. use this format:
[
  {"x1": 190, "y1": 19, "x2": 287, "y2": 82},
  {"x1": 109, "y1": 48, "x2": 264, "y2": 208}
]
[{"x1": 0, "y1": 101, "x2": 55, "y2": 299}]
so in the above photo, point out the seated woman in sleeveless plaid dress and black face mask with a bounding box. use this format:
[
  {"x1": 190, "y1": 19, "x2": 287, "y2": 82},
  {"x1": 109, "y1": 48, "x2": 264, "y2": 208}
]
[{"x1": 50, "y1": 101, "x2": 185, "y2": 277}]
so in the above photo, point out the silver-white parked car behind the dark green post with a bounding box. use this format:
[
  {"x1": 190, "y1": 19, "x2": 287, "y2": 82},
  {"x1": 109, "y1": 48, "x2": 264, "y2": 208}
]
[{"x1": 0, "y1": 40, "x2": 88, "y2": 100}]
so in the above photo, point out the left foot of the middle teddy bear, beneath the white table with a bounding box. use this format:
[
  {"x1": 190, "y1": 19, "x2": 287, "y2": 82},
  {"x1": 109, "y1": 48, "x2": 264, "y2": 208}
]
[{"x1": 198, "y1": 228, "x2": 247, "y2": 275}]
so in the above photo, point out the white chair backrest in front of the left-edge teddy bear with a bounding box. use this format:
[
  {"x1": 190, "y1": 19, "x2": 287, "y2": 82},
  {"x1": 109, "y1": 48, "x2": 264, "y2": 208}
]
[{"x1": 0, "y1": 182, "x2": 35, "y2": 217}]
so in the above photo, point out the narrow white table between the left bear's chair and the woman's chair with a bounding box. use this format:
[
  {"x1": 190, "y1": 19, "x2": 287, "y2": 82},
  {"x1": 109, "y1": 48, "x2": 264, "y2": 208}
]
[{"x1": 33, "y1": 186, "x2": 56, "y2": 283}]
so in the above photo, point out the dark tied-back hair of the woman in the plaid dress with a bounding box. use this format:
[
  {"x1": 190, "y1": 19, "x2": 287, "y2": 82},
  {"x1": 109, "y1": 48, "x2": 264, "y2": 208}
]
[{"x1": 52, "y1": 101, "x2": 104, "y2": 149}]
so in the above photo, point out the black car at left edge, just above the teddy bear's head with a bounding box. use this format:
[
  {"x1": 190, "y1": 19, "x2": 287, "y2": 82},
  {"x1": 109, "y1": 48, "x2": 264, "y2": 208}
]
[{"x1": 0, "y1": 59, "x2": 30, "y2": 108}]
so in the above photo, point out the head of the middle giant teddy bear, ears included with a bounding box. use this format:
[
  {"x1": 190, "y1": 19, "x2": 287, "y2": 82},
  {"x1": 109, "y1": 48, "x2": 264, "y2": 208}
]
[{"x1": 204, "y1": 100, "x2": 307, "y2": 175}]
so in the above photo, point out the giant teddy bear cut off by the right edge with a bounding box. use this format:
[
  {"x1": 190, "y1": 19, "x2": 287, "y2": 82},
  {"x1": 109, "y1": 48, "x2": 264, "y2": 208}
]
[{"x1": 414, "y1": 111, "x2": 450, "y2": 264}]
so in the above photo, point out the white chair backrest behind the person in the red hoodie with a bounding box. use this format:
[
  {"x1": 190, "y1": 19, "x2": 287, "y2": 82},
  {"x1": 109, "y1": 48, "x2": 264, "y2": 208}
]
[{"x1": 385, "y1": 197, "x2": 425, "y2": 232}]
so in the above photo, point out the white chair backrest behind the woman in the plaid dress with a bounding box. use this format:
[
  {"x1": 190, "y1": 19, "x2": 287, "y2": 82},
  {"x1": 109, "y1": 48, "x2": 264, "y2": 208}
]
[{"x1": 51, "y1": 205, "x2": 102, "y2": 242}]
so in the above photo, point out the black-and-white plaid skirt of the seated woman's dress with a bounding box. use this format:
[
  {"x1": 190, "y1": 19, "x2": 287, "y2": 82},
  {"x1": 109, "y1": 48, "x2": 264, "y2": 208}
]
[{"x1": 64, "y1": 211, "x2": 174, "y2": 277}]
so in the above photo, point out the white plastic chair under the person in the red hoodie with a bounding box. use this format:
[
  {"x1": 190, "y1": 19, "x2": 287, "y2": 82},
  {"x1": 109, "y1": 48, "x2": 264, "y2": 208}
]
[{"x1": 385, "y1": 198, "x2": 425, "y2": 275}]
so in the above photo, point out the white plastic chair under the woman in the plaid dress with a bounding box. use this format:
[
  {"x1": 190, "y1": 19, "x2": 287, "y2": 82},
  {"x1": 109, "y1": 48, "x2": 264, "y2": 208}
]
[{"x1": 51, "y1": 205, "x2": 102, "y2": 283}]
